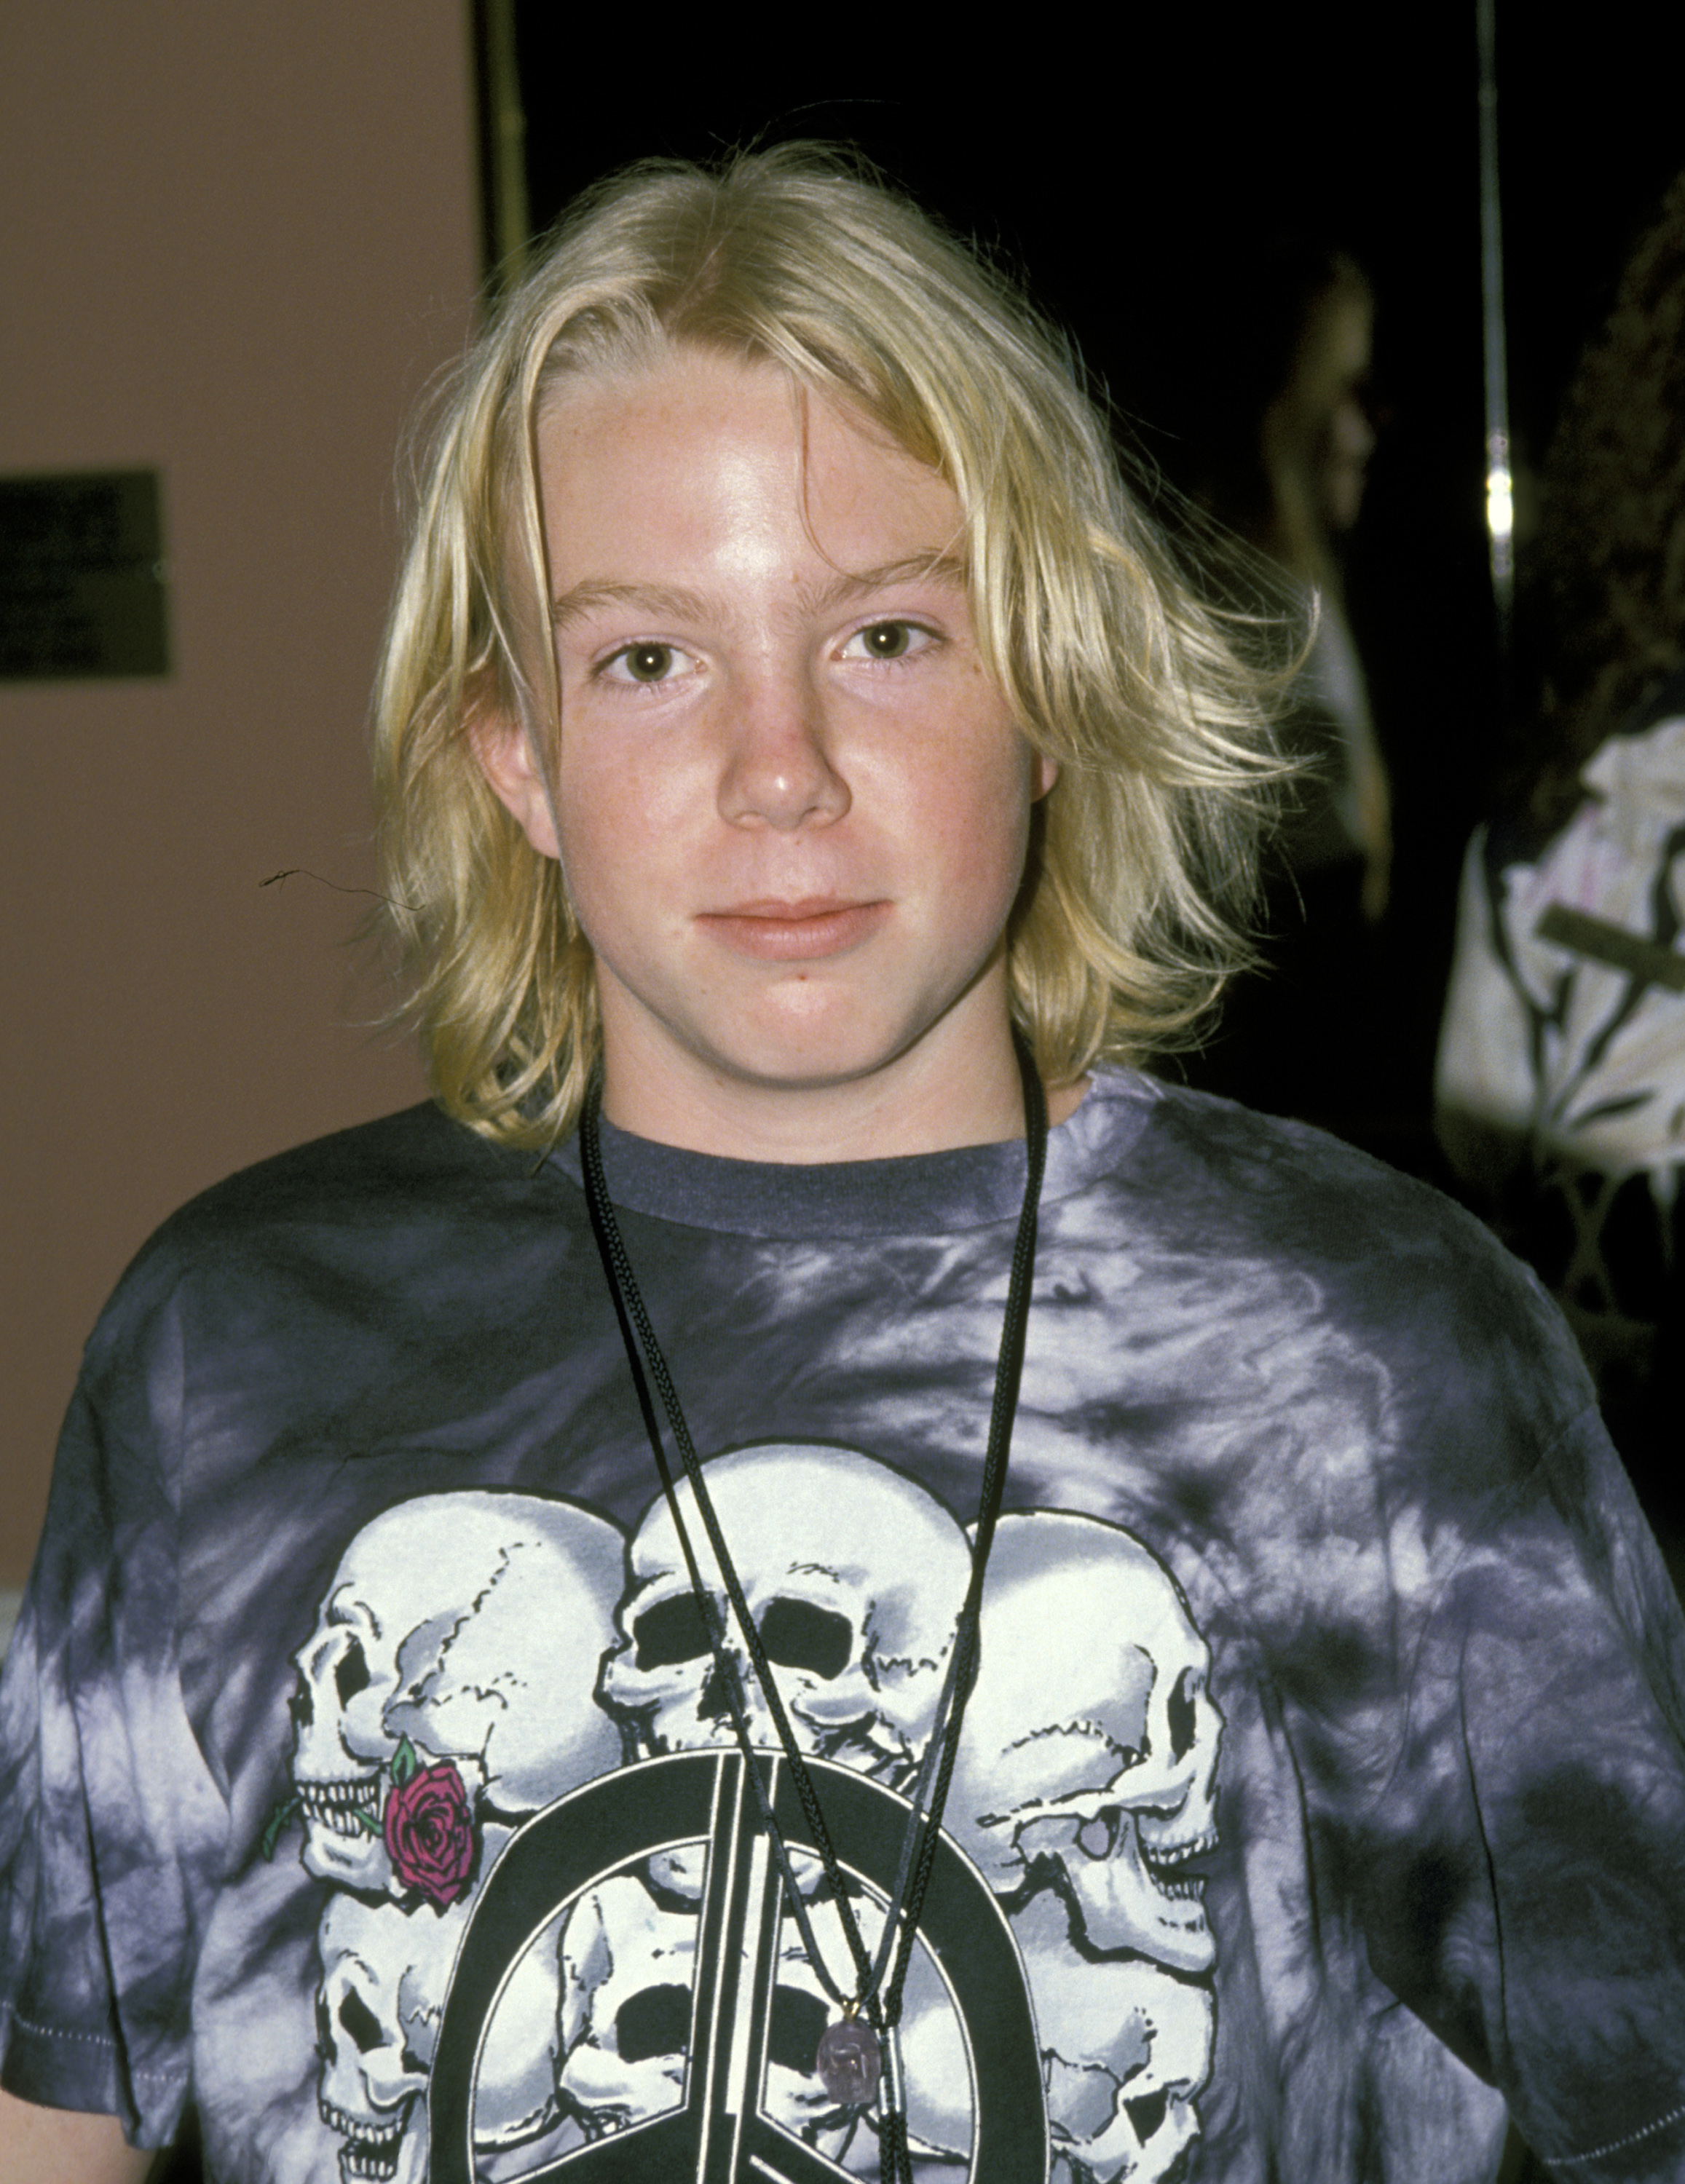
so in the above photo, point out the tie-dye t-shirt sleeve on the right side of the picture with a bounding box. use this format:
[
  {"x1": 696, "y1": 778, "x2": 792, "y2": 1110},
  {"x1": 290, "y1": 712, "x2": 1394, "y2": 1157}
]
[{"x1": 1351, "y1": 1411, "x2": 1685, "y2": 2184}]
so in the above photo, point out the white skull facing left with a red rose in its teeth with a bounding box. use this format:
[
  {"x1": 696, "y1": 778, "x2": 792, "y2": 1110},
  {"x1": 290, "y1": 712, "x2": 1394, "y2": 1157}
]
[{"x1": 291, "y1": 1489, "x2": 623, "y2": 1894}]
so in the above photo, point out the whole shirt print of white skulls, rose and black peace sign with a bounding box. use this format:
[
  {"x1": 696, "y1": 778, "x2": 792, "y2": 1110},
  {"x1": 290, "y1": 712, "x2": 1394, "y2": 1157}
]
[{"x1": 271, "y1": 1446, "x2": 1222, "y2": 2184}]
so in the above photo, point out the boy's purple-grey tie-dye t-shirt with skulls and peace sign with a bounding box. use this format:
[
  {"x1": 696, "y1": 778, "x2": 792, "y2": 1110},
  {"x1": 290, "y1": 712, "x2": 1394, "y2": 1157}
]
[{"x1": 0, "y1": 1075, "x2": 1685, "y2": 2184}]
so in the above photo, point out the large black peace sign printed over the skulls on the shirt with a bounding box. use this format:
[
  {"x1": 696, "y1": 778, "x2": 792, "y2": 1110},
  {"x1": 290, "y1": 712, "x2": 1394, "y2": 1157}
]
[{"x1": 428, "y1": 1752, "x2": 1047, "y2": 2184}]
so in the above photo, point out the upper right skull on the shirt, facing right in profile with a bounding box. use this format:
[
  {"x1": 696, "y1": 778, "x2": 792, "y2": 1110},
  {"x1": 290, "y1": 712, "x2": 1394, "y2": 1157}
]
[{"x1": 947, "y1": 1509, "x2": 1222, "y2": 1972}]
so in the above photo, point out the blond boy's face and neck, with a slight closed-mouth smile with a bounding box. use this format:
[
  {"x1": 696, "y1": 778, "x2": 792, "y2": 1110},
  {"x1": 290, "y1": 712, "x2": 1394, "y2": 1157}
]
[{"x1": 478, "y1": 354, "x2": 1051, "y2": 1158}]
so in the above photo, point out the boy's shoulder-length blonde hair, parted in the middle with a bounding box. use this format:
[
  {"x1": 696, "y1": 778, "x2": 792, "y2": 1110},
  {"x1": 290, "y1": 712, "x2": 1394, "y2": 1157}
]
[{"x1": 376, "y1": 146, "x2": 1279, "y2": 1147}]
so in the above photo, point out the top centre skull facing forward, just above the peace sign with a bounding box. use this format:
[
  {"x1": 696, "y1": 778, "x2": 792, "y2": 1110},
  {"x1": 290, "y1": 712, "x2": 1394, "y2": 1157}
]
[{"x1": 601, "y1": 1446, "x2": 971, "y2": 1787}]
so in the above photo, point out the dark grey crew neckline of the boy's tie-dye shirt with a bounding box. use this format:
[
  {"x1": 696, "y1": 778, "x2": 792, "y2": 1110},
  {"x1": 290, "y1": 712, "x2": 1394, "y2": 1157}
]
[{"x1": 548, "y1": 1070, "x2": 1163, "y2": 1238}]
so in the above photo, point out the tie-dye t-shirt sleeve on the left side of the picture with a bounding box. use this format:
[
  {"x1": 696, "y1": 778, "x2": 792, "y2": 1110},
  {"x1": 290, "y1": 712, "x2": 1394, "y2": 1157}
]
[{"x1": 0, "y1": 1284, "x2": 227, "y2": 2145}]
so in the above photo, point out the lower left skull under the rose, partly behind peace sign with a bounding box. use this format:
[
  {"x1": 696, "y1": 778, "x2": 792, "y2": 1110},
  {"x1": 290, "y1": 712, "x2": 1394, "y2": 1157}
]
[{"x1": 317, "y1": 1828, "x2": 559, "y2": 2184}]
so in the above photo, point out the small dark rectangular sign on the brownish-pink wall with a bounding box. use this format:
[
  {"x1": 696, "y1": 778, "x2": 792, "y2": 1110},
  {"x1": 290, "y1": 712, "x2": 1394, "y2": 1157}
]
[{"x1": 0, "y1": 470, "x2": 170, "y2": 681}]
